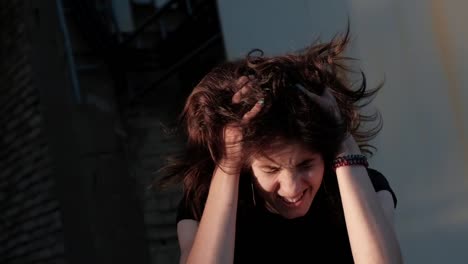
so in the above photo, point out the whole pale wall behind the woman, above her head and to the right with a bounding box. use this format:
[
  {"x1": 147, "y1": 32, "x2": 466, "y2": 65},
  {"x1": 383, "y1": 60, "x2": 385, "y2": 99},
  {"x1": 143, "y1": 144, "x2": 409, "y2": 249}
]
[{"x1": 218, "y1": 0, "x2": 468, "y2": 263}]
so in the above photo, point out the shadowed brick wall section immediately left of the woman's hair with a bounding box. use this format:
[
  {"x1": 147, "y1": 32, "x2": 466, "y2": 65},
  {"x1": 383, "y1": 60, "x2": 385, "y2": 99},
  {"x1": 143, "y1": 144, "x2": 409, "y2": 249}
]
[{"x1": 127, "y1": 79, "x2": 186, "y2": 264}]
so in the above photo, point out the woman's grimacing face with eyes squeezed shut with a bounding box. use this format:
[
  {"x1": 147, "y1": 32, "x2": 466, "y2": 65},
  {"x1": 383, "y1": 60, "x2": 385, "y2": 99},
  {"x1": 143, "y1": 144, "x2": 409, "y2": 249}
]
[{"x1": 251, "y1": 143, "x2": 324, "y2": 219}]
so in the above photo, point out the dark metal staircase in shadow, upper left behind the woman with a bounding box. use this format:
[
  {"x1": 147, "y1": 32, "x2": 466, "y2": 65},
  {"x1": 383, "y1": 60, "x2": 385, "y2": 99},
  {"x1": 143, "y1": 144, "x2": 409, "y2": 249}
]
[{"x1": 57, "y1": 0, "x2": 224, "y2": 109}]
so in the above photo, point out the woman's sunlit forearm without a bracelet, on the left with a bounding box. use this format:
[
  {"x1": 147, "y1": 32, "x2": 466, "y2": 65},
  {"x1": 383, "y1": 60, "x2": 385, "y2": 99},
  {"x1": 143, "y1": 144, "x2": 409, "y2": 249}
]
[{"x1": 187, "y1": 167, "x2": 240, "y2": 264}]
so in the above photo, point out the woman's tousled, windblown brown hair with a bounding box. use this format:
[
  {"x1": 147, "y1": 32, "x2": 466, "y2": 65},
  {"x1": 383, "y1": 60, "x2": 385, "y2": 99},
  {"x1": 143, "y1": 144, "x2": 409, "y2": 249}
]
[{"x1": 158, "y1": 30, "x2": 382, "y2": 219}]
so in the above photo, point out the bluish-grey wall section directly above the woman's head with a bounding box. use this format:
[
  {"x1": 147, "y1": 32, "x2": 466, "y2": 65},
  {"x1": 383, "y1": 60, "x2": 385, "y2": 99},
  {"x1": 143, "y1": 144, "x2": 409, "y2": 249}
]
[{"x1": 218, "y1": 0, "x2": 347, "y2": 59}]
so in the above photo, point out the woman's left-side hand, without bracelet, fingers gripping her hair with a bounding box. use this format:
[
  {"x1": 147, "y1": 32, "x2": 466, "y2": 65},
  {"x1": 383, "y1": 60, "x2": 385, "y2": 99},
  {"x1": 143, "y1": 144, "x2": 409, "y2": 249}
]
[{"x1": 219, "y1": 76, "x2": 264, "y2": 175}]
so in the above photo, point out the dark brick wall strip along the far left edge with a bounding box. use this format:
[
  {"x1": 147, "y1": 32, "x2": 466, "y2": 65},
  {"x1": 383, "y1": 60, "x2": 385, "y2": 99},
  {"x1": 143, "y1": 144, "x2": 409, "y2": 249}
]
[{"x1": 0, "y1": 0, "x2": 64, "y2": 264}]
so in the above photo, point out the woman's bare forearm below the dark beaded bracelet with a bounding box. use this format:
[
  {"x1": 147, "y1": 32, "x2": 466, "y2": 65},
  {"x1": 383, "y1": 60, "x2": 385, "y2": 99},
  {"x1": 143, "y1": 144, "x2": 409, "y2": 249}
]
[{"x1": 336, "y1": 137, "x2": 402, "y2": 264}]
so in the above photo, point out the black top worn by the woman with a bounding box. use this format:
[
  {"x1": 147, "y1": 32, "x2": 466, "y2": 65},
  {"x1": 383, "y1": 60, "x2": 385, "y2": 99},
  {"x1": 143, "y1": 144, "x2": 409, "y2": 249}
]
[{"x1": 176, "y1": 169, "x2": 397, "y2": 263}]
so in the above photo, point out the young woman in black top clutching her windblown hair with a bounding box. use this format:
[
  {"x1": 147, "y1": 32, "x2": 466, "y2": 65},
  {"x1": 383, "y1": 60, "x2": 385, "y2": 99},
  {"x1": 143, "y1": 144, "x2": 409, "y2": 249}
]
[{"x1": 159, "y1": 30, "x2": 402, "y2": 264}]
